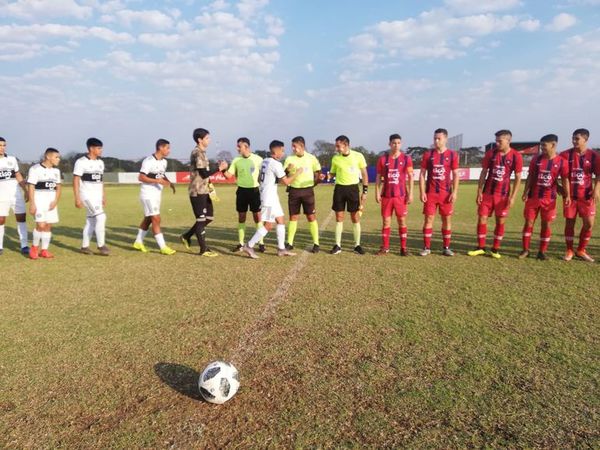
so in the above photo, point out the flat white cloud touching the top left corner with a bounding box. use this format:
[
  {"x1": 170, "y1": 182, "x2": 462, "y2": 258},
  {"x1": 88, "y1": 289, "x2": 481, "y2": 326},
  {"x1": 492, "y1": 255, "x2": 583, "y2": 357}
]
[{"x1": 0, "y1": 0, "x2": 93, "y2": 20}]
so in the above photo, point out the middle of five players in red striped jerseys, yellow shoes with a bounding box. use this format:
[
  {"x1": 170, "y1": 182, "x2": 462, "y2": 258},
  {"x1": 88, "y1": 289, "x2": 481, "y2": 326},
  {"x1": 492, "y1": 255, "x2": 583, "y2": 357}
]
[{"x1": 468, "y1": 130, "x2": 523, "y2": 258}]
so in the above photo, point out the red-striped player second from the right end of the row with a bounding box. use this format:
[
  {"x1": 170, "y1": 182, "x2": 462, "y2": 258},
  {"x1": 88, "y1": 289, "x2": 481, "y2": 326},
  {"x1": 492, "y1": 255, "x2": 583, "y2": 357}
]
[{"x1": 519, "y1": 134, "x2": 571, "y2": 260}]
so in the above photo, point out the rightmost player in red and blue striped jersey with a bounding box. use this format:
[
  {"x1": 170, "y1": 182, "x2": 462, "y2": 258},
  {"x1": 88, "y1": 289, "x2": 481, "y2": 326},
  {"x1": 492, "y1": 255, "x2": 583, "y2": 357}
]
[{"x1": 560, "y1": 128, "x2": 600, "y2": 262}]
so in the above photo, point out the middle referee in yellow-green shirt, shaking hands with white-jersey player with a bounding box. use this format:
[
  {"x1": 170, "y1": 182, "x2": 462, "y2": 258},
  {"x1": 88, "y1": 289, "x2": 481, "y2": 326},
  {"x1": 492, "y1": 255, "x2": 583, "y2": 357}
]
[{"x1": 283, "y1": 136, "x2": 324, "y2": 253}]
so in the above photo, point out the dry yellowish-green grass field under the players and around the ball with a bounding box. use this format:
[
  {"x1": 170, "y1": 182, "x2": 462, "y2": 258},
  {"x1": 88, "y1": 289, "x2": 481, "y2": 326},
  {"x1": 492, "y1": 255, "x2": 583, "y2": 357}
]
[{"x1": 0, "y1": 185, "x2": 600, "y2": 448}]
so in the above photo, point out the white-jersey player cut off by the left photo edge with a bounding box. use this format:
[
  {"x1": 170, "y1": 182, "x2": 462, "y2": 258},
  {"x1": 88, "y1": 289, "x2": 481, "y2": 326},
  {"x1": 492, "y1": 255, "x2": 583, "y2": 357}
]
[{"x1": 0, "y1": 137, "x2": 29, "y2": 255}]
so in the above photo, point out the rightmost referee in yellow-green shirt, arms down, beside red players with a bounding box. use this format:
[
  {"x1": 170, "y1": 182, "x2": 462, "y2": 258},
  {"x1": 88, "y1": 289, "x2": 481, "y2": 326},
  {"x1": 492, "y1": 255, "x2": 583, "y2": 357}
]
[{"x1": 329, "y1": 135, "x2": 369, "y2": 255}]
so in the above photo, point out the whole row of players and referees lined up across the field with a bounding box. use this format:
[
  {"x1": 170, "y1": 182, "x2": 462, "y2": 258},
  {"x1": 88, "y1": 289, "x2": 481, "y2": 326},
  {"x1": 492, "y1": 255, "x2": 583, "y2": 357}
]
[{"x1": 0, "y1": 128, "x2": 600, "y2": 262}]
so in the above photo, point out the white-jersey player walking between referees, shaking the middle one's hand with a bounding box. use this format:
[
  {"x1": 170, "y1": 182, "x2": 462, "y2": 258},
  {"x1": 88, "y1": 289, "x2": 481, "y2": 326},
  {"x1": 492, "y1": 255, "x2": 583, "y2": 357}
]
[{"x1": 242, "y1": 141, "x2": 302, "y2": 259}]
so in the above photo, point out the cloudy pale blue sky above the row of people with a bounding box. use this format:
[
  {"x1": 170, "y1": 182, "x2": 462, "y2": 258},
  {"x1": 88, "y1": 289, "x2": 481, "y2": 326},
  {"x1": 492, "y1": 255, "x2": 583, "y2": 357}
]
[{"x1": 0, "y1": 0, "x2": 600, "y2": 161}]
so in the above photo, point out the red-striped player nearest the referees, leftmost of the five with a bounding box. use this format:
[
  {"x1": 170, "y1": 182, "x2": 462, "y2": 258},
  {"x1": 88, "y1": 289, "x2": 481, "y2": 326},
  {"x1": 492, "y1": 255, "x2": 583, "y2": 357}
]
[{"x1": 375, "y1": 134, "x2": 413, "y2": 256}]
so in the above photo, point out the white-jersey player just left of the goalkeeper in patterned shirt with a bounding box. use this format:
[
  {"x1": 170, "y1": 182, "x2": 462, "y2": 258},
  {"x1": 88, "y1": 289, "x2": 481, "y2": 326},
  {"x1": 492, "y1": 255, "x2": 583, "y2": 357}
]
[{"x1": 133, "y1": 139, "x2": 175, "y2": 255}]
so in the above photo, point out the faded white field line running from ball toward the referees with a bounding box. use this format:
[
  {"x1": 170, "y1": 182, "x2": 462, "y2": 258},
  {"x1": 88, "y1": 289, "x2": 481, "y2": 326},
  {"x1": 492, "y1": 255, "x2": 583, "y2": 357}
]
[{"x1": 231, "y1": 212, "x2": 334, "y2": 366}]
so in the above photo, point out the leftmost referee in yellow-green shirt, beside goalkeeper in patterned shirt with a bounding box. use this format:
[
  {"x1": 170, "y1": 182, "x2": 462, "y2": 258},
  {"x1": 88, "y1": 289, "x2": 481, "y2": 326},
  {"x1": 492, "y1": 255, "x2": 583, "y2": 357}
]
[{"x1": 223, "y1": 137, "x2": 265, "y2": 253}]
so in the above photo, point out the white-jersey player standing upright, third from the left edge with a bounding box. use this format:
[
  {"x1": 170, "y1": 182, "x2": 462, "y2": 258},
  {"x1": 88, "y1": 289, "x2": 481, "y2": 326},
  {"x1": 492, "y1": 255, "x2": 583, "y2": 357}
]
[{"x1": 73, "y1": 138, "x2": 109, "y2": 256}]
